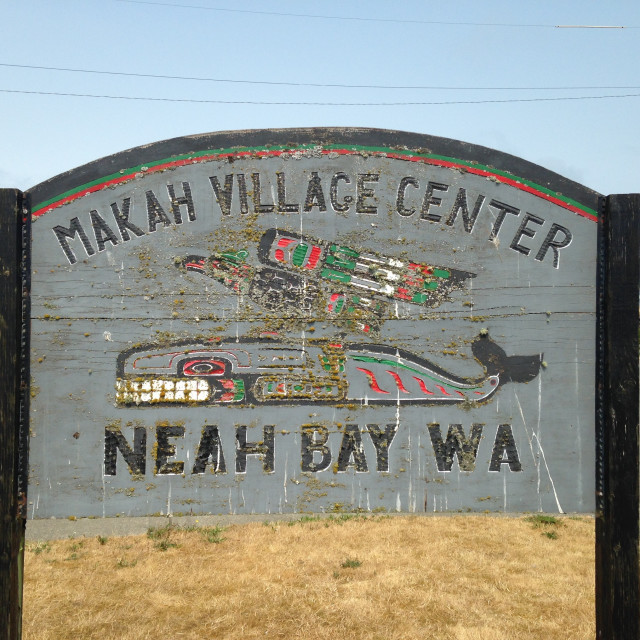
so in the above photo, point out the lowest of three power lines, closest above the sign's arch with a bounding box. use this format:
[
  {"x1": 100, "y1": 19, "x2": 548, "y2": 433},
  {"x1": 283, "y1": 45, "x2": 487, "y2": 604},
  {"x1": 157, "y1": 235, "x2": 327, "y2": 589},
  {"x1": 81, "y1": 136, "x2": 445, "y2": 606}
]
[{"x1": 0, "y1": 89, "x2": 640, "y2": 107}]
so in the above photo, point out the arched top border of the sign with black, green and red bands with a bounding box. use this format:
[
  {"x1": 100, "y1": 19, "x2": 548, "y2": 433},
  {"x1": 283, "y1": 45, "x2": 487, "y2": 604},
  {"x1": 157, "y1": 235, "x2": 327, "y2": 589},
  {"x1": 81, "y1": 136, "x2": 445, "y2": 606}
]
[{"x1": 29, "y1": 128, "x2": 600, "y2": 220}]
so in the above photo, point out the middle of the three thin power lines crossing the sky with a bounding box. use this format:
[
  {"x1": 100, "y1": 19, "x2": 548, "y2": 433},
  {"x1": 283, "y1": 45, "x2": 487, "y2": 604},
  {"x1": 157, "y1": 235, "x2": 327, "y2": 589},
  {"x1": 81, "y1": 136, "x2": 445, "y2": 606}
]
[{"x1": 0, "y1": 62, "x2": 640, "y2": 91}]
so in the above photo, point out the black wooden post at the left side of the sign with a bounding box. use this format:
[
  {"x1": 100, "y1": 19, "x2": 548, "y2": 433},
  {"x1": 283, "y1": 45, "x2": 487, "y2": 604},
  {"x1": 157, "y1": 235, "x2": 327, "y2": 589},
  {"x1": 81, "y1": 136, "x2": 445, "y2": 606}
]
[{"x1": 0, "y1": 189, "x2": 30, "y2": 640}]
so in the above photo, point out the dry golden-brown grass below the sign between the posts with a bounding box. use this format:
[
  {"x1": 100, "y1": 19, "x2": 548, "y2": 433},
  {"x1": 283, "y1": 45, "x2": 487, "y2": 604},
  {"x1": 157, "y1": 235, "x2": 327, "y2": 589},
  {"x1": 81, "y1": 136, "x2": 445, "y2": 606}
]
[{"x1": 23, "y1": 516, "x2": 595, "y2": 640}]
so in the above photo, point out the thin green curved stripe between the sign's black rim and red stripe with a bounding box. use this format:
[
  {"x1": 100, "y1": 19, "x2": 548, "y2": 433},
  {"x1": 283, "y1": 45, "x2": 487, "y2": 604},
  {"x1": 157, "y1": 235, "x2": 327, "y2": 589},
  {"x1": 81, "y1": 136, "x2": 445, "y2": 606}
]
[{"x1": 33, "y1": 143, "x2": 598, "y2": 218}]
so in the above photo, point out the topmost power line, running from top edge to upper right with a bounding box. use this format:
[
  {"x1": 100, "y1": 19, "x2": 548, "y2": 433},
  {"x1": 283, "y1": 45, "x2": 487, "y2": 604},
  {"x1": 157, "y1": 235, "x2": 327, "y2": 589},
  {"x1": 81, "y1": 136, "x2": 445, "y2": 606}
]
[{"x1": 116, "y1": 0, "x2": 638, "y2": 29}]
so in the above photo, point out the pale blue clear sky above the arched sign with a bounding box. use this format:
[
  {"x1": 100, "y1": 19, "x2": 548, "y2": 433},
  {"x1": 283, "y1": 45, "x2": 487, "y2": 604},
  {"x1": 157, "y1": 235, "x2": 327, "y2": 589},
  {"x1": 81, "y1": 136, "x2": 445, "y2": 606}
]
[{"x1": 0, "y1": 0, "x2": 640, "y2": 194}]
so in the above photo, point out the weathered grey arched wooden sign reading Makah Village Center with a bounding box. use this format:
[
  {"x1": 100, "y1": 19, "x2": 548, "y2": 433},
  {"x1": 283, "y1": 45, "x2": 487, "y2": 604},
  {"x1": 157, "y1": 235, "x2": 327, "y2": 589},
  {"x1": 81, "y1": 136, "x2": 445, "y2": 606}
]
[{"x1": 28, "y1": 129, "x2": 599, "y2": 518}]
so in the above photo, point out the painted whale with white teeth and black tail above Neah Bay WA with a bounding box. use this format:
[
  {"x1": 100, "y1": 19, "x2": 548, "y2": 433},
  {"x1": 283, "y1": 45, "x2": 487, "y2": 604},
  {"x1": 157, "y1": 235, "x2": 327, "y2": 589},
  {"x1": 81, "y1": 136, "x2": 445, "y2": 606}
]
[{"x1": 116, "y1": 336, "x2": 542, "y2": 406}]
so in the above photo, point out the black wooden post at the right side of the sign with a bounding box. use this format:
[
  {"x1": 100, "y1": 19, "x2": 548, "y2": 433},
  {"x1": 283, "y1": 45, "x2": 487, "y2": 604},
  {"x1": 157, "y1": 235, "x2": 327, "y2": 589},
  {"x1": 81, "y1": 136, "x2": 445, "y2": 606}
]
[{"x1": 596, "y1": 194, "x2": 640, "y2": 640}]
